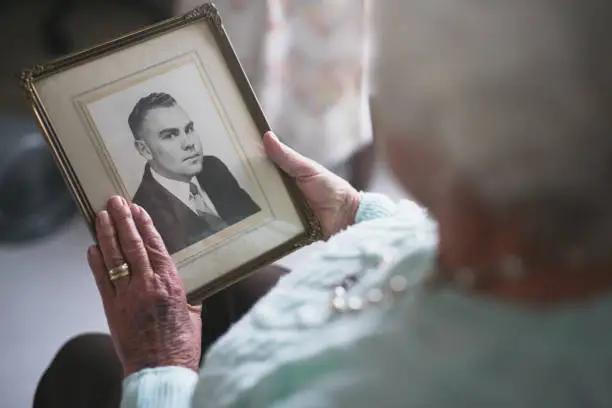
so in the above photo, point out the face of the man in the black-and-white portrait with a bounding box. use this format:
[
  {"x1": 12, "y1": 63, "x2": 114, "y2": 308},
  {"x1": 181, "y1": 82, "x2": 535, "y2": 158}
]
[{"x1": 136, "y1": 105, "x2": 202, "y2": 181}]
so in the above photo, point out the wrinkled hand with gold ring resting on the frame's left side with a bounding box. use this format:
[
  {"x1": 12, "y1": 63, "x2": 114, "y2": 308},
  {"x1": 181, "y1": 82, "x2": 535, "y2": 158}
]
[{"x1": 88, "y1": 196, "x2": 202, "y2": 376}]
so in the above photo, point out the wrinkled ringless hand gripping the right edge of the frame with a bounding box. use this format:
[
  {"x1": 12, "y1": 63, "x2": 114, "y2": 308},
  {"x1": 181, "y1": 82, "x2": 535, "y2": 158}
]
[{"x1": 263, "y1": 132, "x2": 360, "y2": 237}]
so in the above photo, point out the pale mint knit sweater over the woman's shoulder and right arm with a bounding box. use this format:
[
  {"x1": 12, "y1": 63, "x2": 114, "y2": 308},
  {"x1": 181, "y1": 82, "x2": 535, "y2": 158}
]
[{"x1": 194, "y1": 197, "x2": 612, "y2": 408}]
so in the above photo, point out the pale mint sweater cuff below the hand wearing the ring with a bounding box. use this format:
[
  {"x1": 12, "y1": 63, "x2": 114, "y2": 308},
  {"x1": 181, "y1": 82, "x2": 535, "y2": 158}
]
[{"x1": 121, "y1": 367, "x2": 199, "y2": 408}]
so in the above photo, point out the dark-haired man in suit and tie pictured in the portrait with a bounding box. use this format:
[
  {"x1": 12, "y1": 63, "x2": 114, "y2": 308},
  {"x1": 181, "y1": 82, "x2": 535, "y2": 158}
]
[{"x1": 128, "y1": 93, "x2": 261, "y2": 254}]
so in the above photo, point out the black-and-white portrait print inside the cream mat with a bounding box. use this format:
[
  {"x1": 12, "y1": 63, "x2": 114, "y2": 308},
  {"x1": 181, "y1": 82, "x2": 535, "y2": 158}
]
[{"x1": 89, "y1": 60, "x2": 261, "y2": 253}]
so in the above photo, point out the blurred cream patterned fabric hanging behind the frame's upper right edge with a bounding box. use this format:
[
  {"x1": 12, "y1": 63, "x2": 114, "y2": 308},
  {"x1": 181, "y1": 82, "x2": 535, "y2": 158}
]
[{"x1": 177, "y1": 0, "x2": 372, "y2": 167}]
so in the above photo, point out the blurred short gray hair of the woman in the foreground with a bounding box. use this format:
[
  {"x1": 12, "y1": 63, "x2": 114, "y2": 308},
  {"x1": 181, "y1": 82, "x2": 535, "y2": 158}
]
[{"x1": 373, "y1": 0, "x2": 612, "y2": 261}]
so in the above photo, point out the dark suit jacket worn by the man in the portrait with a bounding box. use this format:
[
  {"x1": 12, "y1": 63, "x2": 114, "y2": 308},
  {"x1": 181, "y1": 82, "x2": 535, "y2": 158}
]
[{"x1": 132, "y1": 156, "x2": 261, "y2": 254}]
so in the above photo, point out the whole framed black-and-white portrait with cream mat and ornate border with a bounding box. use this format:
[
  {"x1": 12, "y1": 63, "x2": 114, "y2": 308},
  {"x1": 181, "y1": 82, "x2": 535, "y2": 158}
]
[{"x1": 21, "y1": 3, "x2": 322, "y2": 303}]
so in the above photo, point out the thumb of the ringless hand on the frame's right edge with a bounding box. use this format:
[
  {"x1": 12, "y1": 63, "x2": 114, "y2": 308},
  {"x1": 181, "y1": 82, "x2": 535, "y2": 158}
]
[{"x1": 263, "y1": 132, "x2": 320, "y2": 178}]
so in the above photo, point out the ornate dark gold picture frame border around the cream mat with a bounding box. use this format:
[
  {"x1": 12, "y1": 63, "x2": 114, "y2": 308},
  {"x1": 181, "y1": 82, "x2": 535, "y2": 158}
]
[{"x1": 20, "y1": 3, "x2": 323, "y2": 303}]
